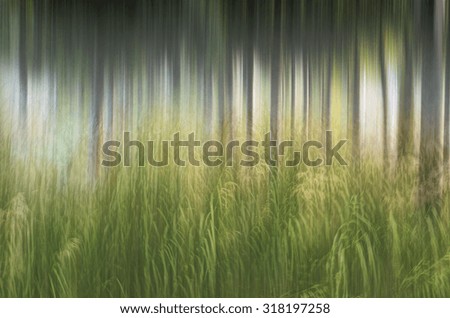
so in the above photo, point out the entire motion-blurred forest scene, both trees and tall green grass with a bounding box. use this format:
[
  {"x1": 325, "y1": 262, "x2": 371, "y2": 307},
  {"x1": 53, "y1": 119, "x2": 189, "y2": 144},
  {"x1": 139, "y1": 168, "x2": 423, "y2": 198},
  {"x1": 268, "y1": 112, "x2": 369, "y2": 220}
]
[{"x1": 0, "y1": 0, "x2": 450, "y2": 297}]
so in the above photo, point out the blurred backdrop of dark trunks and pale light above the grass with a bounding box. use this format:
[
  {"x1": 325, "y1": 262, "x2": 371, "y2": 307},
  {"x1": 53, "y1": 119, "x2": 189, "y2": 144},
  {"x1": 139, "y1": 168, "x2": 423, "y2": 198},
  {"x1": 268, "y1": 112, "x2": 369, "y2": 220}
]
[{"x1": 0, "y1": 0, "x2": 450, "y2": 206}]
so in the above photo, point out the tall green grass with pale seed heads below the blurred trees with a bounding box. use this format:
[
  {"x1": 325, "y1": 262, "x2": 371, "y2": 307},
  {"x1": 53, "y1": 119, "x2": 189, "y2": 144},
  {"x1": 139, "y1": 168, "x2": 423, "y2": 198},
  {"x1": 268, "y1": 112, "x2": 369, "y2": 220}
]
[{"x1": 0, "y1": 123, "x2": 450, "y2": 297}]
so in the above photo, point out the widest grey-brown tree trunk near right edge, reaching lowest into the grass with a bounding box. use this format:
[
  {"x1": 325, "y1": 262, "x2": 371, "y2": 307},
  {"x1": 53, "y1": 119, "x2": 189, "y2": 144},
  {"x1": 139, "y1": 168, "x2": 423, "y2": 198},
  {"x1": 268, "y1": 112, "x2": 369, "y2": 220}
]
[{"x1": 419, "y1": 0, "x2": 443, "y2": 212}]
